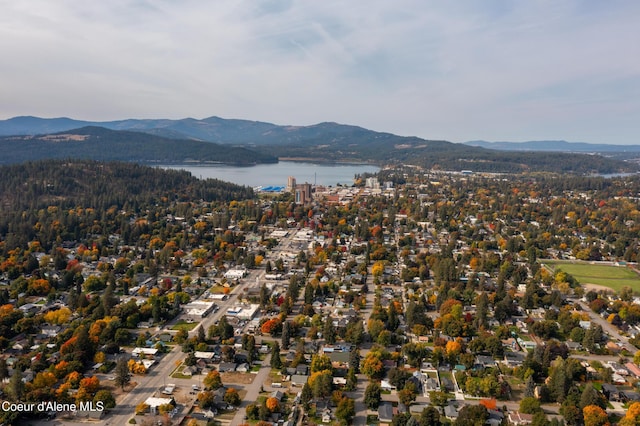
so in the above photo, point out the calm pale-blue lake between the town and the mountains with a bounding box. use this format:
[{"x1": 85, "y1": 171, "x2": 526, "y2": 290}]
[{"x1": 161, "y1": 161, "x2": 380, "y2": 188}]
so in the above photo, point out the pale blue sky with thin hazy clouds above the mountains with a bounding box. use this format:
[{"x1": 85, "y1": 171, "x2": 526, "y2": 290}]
[{"x1": 0, "y1": 0, "x2": 640, "y2": 144}]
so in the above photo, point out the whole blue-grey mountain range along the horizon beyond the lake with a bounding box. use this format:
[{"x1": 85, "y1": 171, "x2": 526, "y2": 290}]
[{"x1": 0, "y1": 117, "x2": 640, "y2": 174}]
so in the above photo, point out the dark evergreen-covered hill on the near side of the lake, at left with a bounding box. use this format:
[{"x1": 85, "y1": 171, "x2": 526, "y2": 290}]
[{"x1": 0, "y1": 160, "x2": 254, "y2": 251}]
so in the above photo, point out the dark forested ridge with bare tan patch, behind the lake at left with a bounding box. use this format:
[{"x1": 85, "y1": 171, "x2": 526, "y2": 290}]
[{"x1": 0, "y1": 127, "x2": 277, "y2": 166}]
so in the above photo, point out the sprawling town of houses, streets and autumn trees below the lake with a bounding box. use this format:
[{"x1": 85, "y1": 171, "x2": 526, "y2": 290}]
[{"x1": 0, "y1": 162, "x2": 640, "y2": 426}]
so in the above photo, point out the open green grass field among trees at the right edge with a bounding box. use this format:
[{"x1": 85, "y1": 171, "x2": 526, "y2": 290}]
[{"x1": 541, "y1": 260, "x2": 640, "y2": 291}]
